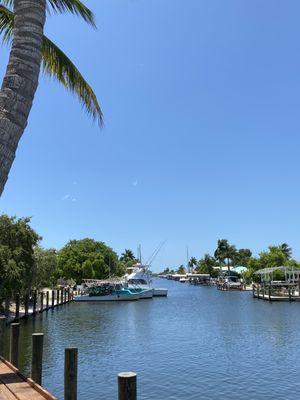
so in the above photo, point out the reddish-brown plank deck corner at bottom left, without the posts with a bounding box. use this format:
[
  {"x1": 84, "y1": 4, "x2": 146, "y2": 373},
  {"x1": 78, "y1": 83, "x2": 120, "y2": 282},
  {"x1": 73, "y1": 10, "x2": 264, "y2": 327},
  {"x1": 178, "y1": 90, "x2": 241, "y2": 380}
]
[{"x1": 0, "y1": 357, "x2": 57, "y2": 400}]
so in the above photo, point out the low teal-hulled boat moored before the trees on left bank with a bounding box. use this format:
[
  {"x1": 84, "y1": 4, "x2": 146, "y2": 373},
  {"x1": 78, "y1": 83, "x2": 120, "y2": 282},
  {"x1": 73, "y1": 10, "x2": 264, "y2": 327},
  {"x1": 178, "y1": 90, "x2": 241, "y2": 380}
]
[{"x1": 74, "y1": 283, "x2": 141, "y2": 301}]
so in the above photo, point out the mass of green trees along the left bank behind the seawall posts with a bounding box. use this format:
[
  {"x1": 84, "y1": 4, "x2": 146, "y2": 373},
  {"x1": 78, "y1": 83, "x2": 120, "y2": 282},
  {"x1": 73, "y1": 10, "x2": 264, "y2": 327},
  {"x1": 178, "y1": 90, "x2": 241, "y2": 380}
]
[{"x1": 0, "y1": 214, "x2": 137, "y2": 316}]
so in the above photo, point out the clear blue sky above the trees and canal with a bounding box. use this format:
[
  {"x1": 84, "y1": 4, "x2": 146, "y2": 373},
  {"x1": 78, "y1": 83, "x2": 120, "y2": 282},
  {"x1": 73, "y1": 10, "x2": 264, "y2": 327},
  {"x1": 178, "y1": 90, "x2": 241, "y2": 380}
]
[{"x1": 0, "y1": 0, "x2": 300, "y2": 269}]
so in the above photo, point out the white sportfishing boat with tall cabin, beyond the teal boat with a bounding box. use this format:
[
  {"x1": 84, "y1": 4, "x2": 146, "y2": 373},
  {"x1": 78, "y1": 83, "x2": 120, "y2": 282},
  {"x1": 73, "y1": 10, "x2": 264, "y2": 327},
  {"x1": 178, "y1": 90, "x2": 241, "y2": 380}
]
[{"x1": 125, "y1": 263, "x2": 168, "y2": 297}]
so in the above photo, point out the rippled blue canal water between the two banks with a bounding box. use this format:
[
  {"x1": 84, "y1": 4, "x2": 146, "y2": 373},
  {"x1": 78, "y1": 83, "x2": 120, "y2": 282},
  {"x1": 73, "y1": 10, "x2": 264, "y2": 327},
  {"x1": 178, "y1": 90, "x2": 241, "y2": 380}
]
[{"x1": 5, "y1": 280, "x2": 300, "y2": 400}]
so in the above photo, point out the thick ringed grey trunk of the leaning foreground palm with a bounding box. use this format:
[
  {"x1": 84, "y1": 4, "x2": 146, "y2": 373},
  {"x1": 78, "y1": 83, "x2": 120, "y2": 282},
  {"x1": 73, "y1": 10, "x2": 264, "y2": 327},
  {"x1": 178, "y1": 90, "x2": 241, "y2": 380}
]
[{"x1": 0, "y1": 0, "x2": 46, "y2": 196}]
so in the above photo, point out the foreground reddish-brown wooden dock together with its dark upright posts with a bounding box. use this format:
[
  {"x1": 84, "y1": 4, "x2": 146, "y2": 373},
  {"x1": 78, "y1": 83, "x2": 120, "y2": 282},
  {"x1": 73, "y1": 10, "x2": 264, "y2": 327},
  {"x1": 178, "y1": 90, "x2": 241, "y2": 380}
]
[{"x1": 0, "y1": 317, "x2": 137, "y2": 400}]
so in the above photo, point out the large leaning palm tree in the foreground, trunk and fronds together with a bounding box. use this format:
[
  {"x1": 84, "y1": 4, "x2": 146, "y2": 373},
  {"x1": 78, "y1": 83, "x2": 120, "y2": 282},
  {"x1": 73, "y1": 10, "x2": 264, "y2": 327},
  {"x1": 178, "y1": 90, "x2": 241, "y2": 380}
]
[{"x1": 0, "y1": 0, "x2": 102, "y2": 196}]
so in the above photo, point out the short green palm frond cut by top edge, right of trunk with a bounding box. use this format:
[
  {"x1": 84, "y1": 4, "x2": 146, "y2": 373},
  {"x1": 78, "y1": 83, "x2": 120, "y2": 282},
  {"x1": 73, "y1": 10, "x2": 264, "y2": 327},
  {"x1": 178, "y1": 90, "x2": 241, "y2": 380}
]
[{"x1": 47, "y1": 0, "x2": 96, "y2": 27}]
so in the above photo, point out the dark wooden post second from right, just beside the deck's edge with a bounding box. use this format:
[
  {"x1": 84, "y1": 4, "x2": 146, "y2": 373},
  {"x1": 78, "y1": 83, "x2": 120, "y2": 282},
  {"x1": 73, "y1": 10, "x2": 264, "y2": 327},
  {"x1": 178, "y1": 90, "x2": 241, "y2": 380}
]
[{"x1": 64, "y1": 348, "x2": 78, "y2": 400}]
